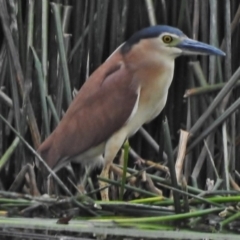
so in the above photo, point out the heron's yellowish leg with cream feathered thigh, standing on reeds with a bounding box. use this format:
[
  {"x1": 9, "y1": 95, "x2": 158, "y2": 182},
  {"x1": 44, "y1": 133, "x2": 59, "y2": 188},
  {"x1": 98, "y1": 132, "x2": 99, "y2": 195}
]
[{"x1": 99, "y1": 129, "x2": 126, "y2": 201}]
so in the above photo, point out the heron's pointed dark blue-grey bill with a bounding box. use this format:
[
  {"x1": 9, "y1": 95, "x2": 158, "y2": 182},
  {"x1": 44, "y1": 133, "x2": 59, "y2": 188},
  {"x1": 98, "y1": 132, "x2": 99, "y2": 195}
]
[{"x1": 177, "y1": 38, "x2": 226, "y2": 56}]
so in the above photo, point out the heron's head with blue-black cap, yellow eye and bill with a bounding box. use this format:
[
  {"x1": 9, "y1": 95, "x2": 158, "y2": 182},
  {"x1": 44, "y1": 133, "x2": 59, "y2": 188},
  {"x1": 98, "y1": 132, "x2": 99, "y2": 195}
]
[{"x1": 121, "y1": 25, "x2": 225, "y2": 58}]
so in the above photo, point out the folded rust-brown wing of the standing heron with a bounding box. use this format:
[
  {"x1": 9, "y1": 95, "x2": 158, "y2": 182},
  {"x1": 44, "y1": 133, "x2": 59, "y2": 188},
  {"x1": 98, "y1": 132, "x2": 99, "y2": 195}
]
[{"x1": 38, "y1": 53, "x2": 137, "y2": 167}]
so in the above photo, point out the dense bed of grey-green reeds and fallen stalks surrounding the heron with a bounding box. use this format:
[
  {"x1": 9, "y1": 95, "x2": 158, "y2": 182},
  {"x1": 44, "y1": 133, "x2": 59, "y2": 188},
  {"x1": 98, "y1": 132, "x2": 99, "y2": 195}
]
[{"x1": 0, "y1": 0, "x2": 240, "y2": 239}]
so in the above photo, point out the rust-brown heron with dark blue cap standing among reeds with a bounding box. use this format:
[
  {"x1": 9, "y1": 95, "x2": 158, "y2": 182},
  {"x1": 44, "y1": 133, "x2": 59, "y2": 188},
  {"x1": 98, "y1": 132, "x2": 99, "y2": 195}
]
[{"x1": 37, "y1": 25, "x2": 225, "y2": 201}]
